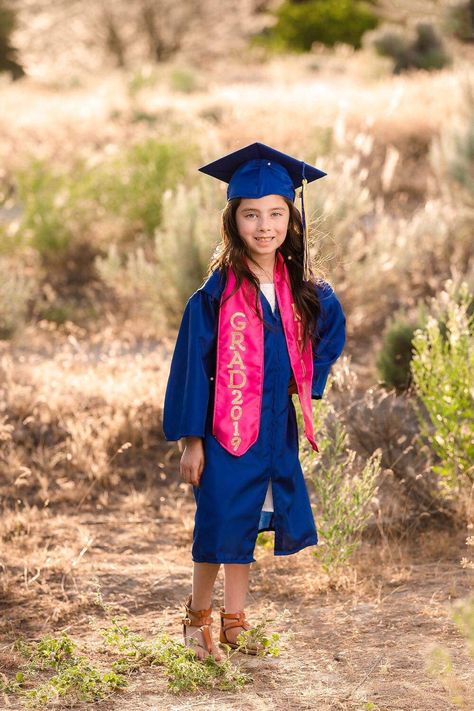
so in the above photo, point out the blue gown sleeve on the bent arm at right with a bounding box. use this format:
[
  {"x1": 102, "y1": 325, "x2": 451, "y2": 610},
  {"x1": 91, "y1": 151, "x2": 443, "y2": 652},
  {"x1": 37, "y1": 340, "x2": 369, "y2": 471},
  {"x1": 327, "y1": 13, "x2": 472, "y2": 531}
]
[{"x1": 311, "y1": 282, "x2": 346, "y2": 400}]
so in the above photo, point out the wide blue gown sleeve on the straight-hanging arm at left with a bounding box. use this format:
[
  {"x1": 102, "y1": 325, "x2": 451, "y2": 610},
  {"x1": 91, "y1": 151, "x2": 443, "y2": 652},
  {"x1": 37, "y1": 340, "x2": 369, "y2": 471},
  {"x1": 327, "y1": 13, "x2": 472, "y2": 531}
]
[{"x1": 163, "y1": 290, "x2": 218, "y2": 441}]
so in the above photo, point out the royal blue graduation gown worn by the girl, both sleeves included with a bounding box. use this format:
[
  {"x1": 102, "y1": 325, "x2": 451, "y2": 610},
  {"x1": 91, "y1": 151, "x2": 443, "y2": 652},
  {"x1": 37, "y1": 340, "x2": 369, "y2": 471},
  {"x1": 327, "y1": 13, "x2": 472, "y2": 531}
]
[{"x1": 163, "y1": 270, "x2": 346, "y2": 563}]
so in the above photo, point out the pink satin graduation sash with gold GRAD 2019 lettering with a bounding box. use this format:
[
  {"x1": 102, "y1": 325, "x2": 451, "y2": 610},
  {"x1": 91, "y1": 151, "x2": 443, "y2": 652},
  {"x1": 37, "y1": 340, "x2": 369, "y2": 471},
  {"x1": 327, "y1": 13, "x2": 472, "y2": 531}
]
[{"x1": 212, "y1": 252, "x2": 319, "y2": 457}]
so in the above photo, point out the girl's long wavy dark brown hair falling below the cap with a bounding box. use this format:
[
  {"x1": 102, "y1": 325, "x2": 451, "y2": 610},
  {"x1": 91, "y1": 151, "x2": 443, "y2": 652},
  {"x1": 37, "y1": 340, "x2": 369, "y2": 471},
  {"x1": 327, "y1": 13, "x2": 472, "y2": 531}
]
[{"x1": 209, "y1": 198, "x2": 321, "y2": 342}]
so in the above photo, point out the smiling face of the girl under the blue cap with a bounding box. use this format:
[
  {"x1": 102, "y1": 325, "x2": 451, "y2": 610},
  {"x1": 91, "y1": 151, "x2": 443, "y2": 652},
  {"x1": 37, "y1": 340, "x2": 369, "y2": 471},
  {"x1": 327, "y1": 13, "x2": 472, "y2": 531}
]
[{"x1": 235, "y1": 195, "x2": 290, "y2": 261}]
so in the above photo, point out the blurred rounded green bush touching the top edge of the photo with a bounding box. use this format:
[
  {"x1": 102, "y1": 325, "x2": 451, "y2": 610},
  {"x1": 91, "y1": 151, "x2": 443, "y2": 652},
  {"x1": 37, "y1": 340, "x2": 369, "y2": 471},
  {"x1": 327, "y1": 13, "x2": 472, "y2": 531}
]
[{"x1": 256, "y1": 0, "x2": 378, "y2": 52}]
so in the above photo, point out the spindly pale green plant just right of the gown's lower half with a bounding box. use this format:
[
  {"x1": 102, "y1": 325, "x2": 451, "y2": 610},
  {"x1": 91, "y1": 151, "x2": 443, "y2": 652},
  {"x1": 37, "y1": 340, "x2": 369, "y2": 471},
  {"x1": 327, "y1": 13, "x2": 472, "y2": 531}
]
[{"x1": 298, "y1": 380, "x2": 382, "y2": 573}]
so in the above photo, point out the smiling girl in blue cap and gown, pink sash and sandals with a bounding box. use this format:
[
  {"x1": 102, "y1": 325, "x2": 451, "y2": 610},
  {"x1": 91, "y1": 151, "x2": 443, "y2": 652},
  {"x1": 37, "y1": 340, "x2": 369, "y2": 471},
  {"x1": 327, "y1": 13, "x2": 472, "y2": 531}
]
[{"x1": 163, "y1": 143, "x2": 346, "y2": 661}]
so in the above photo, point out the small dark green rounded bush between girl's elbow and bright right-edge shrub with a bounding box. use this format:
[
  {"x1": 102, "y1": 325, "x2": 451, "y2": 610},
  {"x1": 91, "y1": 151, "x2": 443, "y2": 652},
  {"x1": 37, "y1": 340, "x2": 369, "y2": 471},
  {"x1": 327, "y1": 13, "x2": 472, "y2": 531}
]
[{"x1": 376, "y1": 315, "x2": 428, "y2": 391}]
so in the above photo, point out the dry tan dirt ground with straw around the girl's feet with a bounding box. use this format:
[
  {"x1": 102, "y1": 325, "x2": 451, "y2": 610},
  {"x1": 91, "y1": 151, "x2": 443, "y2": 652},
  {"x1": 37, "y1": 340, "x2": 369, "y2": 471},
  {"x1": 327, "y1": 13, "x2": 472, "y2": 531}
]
[{"x1": 0, "y1": 478, "x2": 474, "y2": 711}]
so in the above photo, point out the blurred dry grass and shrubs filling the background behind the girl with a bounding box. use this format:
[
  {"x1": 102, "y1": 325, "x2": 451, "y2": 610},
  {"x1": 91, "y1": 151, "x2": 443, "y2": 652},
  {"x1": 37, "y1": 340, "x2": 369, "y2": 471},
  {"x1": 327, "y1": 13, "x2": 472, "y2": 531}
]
[{"x1": 0, "y1": 0, "x2": 474, "y2": 600}]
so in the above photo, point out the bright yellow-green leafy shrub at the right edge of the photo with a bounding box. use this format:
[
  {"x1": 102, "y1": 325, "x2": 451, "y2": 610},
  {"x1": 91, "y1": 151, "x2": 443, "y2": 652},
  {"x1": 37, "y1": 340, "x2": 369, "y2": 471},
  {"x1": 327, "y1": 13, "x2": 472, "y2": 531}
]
[{"x1": 411, "y1": 281, "x2": 474, "y2": 490}]
